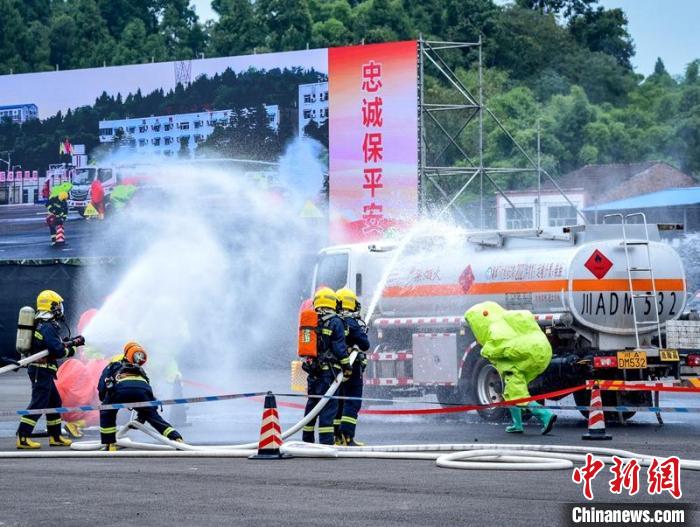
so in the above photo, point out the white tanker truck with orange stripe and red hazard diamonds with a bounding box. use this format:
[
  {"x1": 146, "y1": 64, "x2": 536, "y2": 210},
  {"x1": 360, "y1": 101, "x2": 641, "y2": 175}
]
[{"x1": 312, "y1": 223, "x2": 700, "y2": 420}]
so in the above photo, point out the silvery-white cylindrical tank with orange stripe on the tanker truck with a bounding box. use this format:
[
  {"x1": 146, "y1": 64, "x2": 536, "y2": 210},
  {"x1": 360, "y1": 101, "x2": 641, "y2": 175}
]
[{"x1": 379, "y1": 238, "x2": 685, "y2": 335}]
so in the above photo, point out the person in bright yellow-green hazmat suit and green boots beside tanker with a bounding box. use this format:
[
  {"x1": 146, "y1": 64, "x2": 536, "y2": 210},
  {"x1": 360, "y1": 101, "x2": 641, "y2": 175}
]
[{"x1": 464, "y1": 302, "x2": 557, "y2": 435}]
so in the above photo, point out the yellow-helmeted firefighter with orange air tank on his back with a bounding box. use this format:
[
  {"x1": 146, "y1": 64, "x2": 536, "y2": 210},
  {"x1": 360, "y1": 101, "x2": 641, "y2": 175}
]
[{"x1": 299, "y1": 287, "x2": 352, "y2": 445}]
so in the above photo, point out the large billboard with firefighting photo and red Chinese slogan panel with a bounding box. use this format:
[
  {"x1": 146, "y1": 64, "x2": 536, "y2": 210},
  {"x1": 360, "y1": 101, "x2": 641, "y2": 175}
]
[{"x1": 0, "y1": 41, "x2": 417, "y2": 259}]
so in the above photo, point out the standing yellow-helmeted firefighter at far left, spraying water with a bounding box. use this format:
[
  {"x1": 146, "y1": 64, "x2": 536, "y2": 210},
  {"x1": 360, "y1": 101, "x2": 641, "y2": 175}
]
[{"x1": 17, "y1": 290, "x2": 85, "y2": 449}]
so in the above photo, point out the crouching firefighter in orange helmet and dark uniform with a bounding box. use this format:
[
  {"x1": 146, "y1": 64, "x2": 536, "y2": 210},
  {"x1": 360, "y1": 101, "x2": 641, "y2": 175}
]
[{"x1": 97, "y1": 342, "x2": 182, "y2": 451}]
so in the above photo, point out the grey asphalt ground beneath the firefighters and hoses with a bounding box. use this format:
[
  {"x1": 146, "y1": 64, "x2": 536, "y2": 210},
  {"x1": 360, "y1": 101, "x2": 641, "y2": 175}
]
[{"x1": 0, "y1": 372, "x2": 700, "y2": 527}]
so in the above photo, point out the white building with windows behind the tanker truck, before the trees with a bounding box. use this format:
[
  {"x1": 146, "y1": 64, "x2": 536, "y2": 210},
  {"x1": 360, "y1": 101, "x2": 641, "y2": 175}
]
[{"x1": 496, "y1": 189, "x2": 587, "y2": 230}]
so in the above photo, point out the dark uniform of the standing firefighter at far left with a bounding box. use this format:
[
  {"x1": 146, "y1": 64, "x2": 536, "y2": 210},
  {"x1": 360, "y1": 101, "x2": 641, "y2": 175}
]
[{"x1": 17, "y1": 320, "x2": 75, "y2": 438}]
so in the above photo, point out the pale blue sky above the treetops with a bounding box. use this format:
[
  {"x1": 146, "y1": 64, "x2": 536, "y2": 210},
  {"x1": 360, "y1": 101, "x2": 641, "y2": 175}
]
[{"x1": 192, "y1": 0, "x2": 700, "y2": 75}]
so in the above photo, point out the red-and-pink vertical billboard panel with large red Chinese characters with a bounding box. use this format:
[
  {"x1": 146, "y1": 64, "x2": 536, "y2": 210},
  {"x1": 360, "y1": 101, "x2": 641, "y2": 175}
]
[{"x1": 328, "y1": 41, "x2": 418, "y2": 241}]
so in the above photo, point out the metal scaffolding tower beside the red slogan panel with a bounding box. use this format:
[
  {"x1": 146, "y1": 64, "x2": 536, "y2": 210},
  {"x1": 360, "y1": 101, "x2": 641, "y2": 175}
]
[{"x1": 418, "y1": 36, "x2": 586, "y2": 229}]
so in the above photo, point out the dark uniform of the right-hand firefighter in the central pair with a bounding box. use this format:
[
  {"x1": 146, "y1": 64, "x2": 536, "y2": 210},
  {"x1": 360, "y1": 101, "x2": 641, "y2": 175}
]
[{"x1": 334, "y1": 313, "x2": 369, "y2": 438}]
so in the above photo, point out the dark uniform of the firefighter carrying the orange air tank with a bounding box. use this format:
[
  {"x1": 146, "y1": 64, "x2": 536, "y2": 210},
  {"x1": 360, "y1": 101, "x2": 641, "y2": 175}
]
[{"x1": 302, "y1": 313, "x2": 350, "y2": 445}]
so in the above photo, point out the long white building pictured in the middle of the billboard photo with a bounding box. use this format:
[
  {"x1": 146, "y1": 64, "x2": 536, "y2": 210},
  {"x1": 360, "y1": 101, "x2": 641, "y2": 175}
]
[{"x1": 100, "y1": 104, "x2": 279, "y2": 156}]
